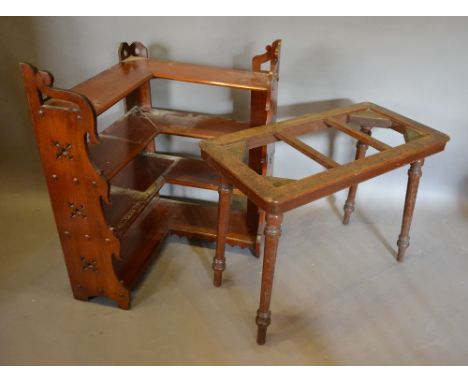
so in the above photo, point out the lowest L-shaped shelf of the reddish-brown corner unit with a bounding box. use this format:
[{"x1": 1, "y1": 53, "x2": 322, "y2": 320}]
[{"x1": 114, "y1": 197, "x2": 257, "y2": 288}]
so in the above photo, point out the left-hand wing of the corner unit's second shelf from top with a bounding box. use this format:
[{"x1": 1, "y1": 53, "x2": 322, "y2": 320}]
[{"x1": 88, "y1": 109, "x2": 157, "y2": 179}]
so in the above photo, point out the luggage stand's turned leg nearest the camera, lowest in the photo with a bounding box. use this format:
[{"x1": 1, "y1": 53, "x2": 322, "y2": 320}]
[{"x1": 255, "y1": 214, "x2": 283, "y2": 345}]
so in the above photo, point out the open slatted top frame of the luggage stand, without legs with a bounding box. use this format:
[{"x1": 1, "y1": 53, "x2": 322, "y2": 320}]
[{"x1": 200, "y1": 103, "x2": 449, "y2": 213}]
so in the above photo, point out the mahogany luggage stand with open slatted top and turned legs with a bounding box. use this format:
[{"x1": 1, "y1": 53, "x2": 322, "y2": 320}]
[{"x1": 200, "y1": 103, "x2": 449, "y2": 344}]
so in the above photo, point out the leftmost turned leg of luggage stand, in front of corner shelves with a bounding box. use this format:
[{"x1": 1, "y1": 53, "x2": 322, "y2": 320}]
[{"x1": 212, "y1": 180, "x2": 232, "y2": 287}]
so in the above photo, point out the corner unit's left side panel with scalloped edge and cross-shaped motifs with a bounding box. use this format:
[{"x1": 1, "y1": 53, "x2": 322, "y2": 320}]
[{"x1": 21, "y1": 64, "x2": 130, "y2": 309}]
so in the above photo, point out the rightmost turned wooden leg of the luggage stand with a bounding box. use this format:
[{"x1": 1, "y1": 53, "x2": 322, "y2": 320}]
[{"x1": 397, "y1": 159, "x2": 424, "y2": 261}]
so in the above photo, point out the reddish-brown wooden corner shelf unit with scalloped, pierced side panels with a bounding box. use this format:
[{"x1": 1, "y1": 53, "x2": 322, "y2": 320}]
[{"x1": 20, "y1": 40, "x2": 281, "y2": 309}]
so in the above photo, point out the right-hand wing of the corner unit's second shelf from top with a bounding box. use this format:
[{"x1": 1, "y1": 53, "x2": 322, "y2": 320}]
[{"x1": 145, "y1": 109, "x2": 250, "y2": 139}]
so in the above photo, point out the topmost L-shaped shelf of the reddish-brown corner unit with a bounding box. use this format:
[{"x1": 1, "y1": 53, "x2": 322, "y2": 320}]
[{"x1": 70, "y1": 58, "x2": 271, "y2": 115}]
